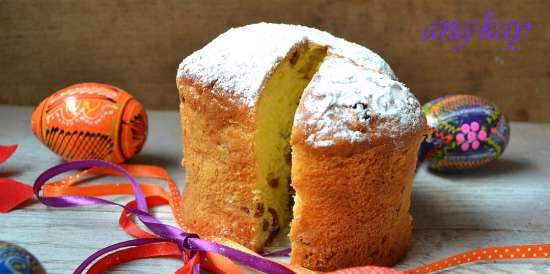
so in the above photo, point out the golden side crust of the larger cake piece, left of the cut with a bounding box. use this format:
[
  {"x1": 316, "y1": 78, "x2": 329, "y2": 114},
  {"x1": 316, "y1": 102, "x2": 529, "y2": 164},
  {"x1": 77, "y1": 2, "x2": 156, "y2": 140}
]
[{"x1": 178, "y1": 78, "x2": 263, "y2": 250}]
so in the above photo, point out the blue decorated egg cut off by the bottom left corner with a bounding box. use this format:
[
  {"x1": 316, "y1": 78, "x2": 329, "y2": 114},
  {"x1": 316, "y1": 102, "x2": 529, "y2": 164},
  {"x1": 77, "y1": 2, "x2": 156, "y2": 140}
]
[{"x1": 0, "y1": 242, "x2": 46, "y2": 274}]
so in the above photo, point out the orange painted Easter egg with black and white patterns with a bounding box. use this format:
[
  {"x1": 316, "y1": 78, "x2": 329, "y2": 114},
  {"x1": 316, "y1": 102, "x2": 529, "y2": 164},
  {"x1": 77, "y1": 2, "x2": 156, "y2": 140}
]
[{"x1": 31, "y1": 83, "x2": 147, "y2": 163}]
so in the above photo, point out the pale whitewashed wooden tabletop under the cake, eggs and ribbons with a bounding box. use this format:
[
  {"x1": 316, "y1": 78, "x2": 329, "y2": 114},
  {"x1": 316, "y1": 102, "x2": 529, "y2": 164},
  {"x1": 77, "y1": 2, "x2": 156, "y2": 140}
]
[{"x1": 0, "y1": 106, "x2": 550, "y2": 274}]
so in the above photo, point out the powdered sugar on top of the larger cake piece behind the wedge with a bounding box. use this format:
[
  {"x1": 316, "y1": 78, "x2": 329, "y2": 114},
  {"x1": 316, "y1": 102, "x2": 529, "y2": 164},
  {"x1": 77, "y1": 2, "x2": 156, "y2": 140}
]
[{"x1": 177, "y1": 23, "x2": 395, "y2": 108}]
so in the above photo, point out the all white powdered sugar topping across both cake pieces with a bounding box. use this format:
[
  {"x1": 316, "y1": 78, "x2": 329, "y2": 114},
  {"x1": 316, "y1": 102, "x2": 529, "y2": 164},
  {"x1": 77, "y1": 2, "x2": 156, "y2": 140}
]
[{"x1": 177, "y1": 23, "x2": 424, "y2": 147}]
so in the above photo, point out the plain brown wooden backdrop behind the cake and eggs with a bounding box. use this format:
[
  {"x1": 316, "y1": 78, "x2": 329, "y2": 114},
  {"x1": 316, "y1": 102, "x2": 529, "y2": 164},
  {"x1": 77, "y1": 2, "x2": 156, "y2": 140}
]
[{"x1": 0, "y1": 0, "x2": 550, "y2": 122}]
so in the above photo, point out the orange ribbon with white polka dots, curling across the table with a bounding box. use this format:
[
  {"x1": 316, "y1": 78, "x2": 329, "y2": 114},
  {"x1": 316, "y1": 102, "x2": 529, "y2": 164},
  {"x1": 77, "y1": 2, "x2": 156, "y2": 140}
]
[{"x1": 29, "y1": 158, "x2": 550, "y2": 274}]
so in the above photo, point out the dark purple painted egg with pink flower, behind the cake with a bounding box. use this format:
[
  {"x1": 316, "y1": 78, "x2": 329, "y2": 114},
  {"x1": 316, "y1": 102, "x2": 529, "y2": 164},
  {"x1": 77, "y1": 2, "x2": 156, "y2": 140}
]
[{"x1": 420, "y1": 95, "x2": 510, "y2": 171}]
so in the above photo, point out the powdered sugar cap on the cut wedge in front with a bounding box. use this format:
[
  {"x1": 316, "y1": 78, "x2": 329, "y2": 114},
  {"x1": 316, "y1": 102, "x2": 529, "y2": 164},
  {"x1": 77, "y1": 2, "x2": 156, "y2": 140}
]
[{"x1": 295, "y1": 56, "x2": 423, "y2": 147}]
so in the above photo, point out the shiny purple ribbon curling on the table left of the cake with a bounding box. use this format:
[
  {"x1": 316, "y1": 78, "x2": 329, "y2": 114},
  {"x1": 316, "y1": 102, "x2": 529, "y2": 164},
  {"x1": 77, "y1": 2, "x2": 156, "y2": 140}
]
[{"x1": 33, "y1": 160, "x2": 294, "y2": 274}]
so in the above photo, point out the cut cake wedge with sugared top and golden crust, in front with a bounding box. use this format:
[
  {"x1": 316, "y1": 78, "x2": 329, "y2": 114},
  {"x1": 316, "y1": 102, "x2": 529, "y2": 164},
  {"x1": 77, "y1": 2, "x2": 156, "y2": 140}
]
[{"x1": 290, "y1": 56, "x2": 425, "y2": 271}]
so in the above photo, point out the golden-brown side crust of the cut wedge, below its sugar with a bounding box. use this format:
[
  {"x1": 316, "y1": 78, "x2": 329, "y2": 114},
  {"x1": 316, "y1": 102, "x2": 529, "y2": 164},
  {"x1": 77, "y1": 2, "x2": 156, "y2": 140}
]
[{"x1": 289, "y1": 133, "x2": 430, "y2": 271}]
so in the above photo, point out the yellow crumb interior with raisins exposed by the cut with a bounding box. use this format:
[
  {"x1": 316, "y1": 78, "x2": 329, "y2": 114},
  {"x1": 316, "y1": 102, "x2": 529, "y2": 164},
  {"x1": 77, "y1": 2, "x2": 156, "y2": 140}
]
[{"x1": 252, "y1": 43, "x2": 327, "y2": 246}]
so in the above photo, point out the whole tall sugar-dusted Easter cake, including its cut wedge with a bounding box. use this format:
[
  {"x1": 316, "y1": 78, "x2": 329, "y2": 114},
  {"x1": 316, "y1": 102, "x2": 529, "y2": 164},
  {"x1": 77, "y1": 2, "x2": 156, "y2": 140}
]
[{"x1": 177, "y1": 23, "x2": 426, "y2": 271}]
